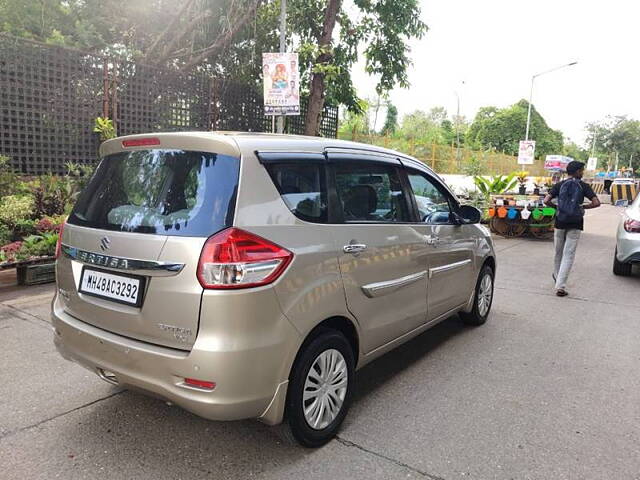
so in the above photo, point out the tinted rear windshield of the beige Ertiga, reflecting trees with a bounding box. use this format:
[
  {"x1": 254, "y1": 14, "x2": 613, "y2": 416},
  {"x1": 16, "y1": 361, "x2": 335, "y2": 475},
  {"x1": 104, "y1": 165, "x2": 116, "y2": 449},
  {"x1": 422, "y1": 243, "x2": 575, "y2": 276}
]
[{"x1": 68, "y1": 150, "x2": 240, "y2": 237}]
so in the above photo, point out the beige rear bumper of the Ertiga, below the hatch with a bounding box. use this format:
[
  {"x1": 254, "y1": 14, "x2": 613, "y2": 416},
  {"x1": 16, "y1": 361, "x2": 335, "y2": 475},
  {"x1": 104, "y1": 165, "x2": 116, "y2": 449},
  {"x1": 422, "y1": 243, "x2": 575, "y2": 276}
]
[{"x1": 52, "y1": 298, "x2": 300, "y2": 424}]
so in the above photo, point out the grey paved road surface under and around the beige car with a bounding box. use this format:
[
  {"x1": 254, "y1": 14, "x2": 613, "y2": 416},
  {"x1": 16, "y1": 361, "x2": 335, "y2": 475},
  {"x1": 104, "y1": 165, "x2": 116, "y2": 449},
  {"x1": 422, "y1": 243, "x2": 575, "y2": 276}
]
[{"x1": 0, "y1": 206, "x2": 640, "y2": 480}]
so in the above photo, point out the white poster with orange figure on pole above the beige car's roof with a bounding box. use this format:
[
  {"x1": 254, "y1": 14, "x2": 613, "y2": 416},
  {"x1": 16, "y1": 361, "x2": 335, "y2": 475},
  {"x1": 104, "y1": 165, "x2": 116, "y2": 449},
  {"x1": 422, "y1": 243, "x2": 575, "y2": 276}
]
[{"x1": 262, "y1": 53, "x2": 300, "y2": 115}]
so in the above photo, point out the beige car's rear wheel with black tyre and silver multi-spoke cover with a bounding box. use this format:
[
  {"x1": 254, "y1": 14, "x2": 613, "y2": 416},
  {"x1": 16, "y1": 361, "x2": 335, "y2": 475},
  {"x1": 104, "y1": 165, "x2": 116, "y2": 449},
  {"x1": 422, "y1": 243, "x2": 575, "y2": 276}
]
[{"x1": 278, "y1": 330, "x2": 355, "y2": 448}]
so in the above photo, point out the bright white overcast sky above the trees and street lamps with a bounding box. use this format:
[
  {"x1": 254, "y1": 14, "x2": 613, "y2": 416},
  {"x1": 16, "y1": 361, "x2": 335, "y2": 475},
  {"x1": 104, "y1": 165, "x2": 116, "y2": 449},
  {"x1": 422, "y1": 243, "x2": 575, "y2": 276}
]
[{"x1": 353, "y1": 0, "x2": 640, "y2": 144}]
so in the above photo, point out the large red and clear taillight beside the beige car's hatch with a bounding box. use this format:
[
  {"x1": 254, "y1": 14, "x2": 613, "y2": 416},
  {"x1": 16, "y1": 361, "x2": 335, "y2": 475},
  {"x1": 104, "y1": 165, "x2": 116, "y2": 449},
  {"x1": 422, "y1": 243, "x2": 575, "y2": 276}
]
[{"x1": 198, "y1": 228, "x2": 293, "y2": 289}]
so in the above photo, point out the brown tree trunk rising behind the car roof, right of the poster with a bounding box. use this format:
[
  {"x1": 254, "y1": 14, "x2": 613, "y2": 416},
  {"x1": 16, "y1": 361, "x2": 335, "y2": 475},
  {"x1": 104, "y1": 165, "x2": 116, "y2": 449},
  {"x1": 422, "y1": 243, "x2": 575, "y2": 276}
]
[{"x1": 304, "y1": 0, "x2": 341, "y2": 135}]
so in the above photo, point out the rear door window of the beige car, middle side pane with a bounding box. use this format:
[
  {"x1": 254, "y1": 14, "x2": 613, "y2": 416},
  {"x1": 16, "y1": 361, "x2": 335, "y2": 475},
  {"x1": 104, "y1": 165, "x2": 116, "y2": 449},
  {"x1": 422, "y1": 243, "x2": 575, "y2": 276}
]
[{"x1": 334, "y1": 162, "x2": 411, "y2": 223}]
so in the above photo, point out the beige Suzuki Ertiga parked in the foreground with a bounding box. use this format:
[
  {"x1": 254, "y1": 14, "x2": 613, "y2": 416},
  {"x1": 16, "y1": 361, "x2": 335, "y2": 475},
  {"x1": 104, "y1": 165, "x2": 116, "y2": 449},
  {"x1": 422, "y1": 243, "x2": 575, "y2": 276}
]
[{"x1": 52, "y1": 132, "x2": 496, "y2": 447}]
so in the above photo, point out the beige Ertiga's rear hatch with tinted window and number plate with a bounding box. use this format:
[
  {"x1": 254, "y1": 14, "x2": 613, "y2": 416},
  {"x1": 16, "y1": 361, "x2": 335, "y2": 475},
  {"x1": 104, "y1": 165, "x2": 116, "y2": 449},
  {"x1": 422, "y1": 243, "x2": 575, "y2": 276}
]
[{"x1": 57, "y1": 134, "x2": 240, "y2": 350}]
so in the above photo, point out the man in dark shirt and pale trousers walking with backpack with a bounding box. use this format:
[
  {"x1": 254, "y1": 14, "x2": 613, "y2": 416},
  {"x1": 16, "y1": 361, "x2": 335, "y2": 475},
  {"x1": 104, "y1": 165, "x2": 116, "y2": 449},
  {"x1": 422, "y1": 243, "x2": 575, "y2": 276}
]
[{"x1": 544, "y1": 161, "x2": 600, "y2": 297}]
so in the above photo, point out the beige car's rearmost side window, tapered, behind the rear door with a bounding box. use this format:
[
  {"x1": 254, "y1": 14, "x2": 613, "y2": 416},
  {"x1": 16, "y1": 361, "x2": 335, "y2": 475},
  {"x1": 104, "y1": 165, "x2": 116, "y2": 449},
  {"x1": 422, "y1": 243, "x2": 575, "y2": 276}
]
[{"x1": 267, "y1": 162, "x2": 327, "y2": 223}]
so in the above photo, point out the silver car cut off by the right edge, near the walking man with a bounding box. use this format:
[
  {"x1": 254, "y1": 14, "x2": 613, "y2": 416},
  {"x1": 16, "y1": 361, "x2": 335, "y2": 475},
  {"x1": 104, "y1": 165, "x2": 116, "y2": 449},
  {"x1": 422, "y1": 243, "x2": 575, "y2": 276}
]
[{"x1": 613, "y1": 190, "x2": 640, "y2": 276}]
